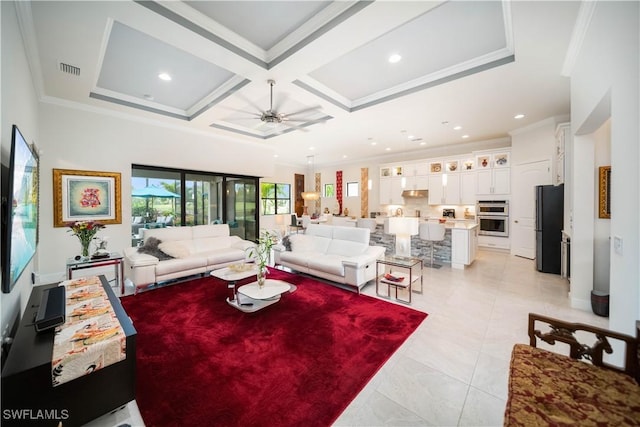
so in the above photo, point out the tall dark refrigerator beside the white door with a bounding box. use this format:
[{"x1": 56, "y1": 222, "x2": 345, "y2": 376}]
[{"x1": 536, "y1": 185, "x2": 564, "y2": 274}]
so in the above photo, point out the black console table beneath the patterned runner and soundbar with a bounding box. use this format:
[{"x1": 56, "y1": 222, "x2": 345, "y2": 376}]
[{"x1": 1, "y1": 276, "x2": 136, "y2": 427}]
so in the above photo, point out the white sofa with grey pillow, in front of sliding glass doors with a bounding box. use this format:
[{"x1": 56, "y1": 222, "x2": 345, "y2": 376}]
[{"x1": 124, "y1": 224, "x2": 255, "y2": 292}]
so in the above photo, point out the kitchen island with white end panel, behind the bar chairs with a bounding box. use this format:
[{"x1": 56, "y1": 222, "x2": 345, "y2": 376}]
[{"x1": 370, "y1": 221, "x2": 478, "y2": 269}]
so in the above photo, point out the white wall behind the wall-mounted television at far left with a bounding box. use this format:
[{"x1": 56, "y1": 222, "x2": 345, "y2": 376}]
[{"x1": 0, "y1": 1, "x2": 42, "y2": 338}]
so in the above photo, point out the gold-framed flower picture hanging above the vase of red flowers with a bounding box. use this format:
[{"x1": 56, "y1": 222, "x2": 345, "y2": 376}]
[{"x1": 53, "y1": 169, "x2": 122, "y2": 227}]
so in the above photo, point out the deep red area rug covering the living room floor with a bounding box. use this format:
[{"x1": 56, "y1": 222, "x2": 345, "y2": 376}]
[{"x1": 122, "y1": 270, "x2": 427, "y2": 427}]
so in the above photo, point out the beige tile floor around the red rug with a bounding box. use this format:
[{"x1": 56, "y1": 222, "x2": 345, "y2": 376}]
[{"x1": 89, "y1": 251, "x2": 608, "y2": 427}]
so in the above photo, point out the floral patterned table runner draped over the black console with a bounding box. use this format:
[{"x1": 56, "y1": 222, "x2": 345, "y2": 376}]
[{"x1": 51, "y1": 276, "x2": 126, "y2": 387}]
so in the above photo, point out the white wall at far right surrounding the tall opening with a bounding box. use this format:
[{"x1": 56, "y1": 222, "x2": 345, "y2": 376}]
[{"x1": 570, "y1": 2, "x2": 640, "y2": 334}]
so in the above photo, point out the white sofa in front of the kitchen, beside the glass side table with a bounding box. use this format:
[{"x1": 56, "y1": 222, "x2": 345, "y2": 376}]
[{"x1": 274, "y1": 224, "x2": 385, "y2": 291}]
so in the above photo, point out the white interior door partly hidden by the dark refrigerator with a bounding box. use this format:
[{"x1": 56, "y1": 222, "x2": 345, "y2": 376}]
[{"x1": 510, "y1": 160, "x2": 551, "y2": 259}]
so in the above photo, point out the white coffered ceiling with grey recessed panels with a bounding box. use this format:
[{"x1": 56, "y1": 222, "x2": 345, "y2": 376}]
[{"x1": 18, "y1": 0, "x2": 580, "y2": 165}]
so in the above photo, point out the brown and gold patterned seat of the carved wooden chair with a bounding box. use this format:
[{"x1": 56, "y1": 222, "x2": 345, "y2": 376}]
[{"x1": 504, "y1": 344, "x2": 640, "y2": 426}]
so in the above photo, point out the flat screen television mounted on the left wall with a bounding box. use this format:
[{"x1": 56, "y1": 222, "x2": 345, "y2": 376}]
[{"x1": 2, "y1": 125, "x2": 39, "y2": 293}]
